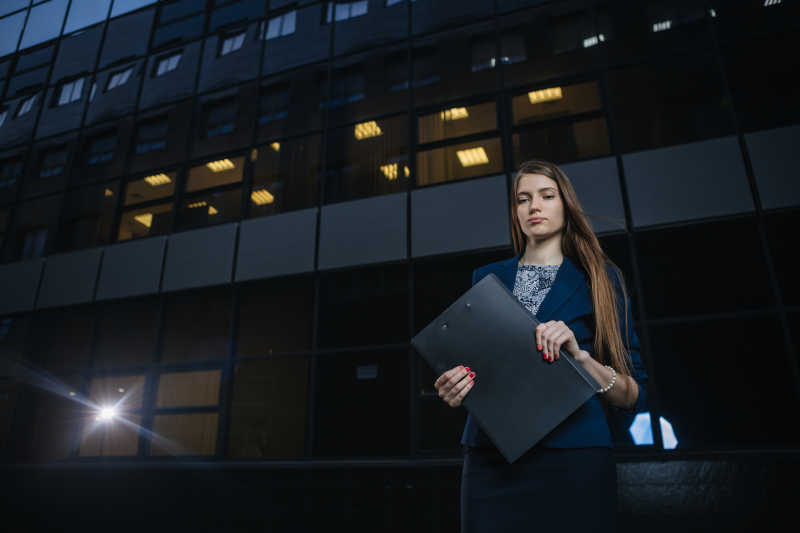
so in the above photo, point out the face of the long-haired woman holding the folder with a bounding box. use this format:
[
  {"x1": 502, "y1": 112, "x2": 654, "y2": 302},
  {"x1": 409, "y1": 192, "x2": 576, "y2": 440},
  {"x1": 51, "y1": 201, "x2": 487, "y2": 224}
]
[{"x1": 516, "y1": 174, "x2": 564, "y2": 242}]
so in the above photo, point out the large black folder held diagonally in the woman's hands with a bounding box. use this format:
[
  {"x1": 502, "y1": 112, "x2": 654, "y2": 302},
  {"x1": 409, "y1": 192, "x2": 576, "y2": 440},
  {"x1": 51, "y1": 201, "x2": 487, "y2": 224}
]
[{"x1": 411, "y1": 273, "x2": 600, "y2": 463}]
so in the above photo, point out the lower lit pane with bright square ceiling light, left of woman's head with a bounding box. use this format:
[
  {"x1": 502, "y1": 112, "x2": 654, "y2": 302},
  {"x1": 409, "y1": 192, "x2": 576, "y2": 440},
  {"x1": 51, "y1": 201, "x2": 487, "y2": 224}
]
[{"x1": 417, "y1": 138, "x2": 503, "y2": 186}]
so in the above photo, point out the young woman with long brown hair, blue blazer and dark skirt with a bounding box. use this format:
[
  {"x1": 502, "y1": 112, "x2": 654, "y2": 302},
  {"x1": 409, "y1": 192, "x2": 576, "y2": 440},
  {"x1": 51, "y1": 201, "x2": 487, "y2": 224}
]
[{"x1": 434, "y1": 161, "x2": 647, "y2": 532}]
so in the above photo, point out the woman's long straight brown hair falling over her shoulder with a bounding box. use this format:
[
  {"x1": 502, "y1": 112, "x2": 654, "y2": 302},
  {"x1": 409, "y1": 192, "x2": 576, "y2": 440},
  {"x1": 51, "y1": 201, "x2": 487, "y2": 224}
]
[{"x1": 510, "y1": 160, "x2": 631, "y2": 375}]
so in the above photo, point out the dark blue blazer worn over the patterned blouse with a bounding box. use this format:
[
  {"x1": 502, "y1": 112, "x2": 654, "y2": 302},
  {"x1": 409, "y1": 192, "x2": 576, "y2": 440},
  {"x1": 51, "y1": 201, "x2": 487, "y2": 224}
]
[{"x1": 461, "y1": 253, "x2": 647, "y2": 448}]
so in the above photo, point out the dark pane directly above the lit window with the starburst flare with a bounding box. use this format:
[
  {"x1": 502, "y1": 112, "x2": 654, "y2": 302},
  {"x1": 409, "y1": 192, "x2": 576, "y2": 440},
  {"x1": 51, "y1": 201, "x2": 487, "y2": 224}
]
[{"x1": 94, "y1": 296, "x2": 159, "y2": 369}]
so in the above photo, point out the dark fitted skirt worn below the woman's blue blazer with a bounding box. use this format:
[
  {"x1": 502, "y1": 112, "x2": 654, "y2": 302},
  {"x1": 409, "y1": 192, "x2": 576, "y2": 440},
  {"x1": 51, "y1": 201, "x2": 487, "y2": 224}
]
[{"x1": 461, "y1": 446, "x2": 617, "y2": 533}]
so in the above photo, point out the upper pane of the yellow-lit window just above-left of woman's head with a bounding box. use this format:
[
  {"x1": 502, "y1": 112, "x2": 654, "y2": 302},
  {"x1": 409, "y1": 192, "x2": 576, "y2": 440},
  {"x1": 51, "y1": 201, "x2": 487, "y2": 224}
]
[{"x1": 417, "y1": 102, "x2": 497, "y2": 143}]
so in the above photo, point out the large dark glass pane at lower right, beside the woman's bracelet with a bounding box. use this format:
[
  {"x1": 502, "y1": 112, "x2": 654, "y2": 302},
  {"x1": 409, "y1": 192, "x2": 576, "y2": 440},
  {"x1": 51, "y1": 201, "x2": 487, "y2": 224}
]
[{"x1": 651, "y1": 316, "x2": 800, "y2": 449}]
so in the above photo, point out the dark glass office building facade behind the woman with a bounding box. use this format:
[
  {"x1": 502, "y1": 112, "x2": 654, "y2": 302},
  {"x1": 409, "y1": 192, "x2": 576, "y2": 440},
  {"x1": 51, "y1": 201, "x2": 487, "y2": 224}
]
[{"x1": 0, "y1": 0, "x2": 800, "y2": 470}]
